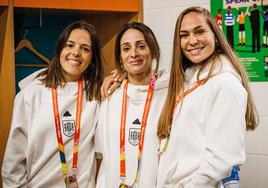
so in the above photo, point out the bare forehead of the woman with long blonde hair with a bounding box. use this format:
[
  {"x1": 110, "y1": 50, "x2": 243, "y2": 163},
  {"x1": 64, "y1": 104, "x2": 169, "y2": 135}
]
[{"x1": 180, "y1": 12, "x2": 209, "y2": 30}]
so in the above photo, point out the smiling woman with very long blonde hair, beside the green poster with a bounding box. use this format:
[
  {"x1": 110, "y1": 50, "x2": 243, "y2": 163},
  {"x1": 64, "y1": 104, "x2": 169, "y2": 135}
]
[{"x1": 157, "y1": 7, "x2": 258, "y2": 188}]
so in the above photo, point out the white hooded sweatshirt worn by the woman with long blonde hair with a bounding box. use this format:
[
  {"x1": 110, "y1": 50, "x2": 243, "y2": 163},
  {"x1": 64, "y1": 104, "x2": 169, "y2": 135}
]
[{"x1": 157, "y1": 56, "x2": 247, "y2": 188}]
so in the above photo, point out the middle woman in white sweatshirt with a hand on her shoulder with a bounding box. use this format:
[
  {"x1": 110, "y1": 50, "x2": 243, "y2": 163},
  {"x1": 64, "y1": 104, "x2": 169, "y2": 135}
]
[{"x1": 96, "y1": 22, "x2": 168, "y2": 188}]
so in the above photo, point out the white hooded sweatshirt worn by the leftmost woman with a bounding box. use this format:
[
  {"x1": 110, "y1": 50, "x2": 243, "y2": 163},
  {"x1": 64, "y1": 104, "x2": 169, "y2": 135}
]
[{"x1": 2, "y1": 73, "x2": 99, "y2": 188}]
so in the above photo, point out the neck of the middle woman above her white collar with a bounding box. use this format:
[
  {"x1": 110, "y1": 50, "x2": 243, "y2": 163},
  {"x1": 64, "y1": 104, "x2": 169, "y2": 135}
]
[{"x1": 128, "y1": 71, "x2": 152, "y2": 85}]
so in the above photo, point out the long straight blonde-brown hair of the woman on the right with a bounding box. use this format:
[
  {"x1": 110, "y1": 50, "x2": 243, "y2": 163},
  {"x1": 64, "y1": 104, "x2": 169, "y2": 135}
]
[{"x1": 157, "y1": 6, "x2": 259, "y2": 139}]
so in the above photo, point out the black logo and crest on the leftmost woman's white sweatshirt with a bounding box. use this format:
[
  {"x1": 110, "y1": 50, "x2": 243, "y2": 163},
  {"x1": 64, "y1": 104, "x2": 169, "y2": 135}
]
[{"x1": 62, "y1": 111, "x2": 75, "y2": 137}]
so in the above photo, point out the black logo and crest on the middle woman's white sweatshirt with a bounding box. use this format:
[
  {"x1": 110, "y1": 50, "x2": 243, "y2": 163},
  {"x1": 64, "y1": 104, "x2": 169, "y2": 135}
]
[{"x1": 128, "y1": 119, "x2": 141, "y2": 146}]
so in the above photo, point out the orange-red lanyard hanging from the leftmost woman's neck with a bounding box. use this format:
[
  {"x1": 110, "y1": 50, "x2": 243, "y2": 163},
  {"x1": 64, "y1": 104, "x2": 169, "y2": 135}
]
[{"x1": 52, "y1": 79, "x2": 83, "y2": 177}]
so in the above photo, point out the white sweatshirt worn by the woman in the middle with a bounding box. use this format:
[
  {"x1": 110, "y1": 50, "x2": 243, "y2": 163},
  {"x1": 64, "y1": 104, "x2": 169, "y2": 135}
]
[{"x1": 96, "y1": 71, "x2": 168, "y2": 188}]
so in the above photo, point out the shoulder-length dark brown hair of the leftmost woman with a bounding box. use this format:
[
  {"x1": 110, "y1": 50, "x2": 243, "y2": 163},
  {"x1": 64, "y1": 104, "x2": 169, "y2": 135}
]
[{"x1": 37, "y1": 20, "x2": 103, "y2": 100}]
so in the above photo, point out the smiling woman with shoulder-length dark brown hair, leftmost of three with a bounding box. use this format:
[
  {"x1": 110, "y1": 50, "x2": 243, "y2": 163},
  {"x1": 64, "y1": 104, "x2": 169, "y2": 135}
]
[{"x1": 2, "y1": 21, "x2": 103, "y2": 187}]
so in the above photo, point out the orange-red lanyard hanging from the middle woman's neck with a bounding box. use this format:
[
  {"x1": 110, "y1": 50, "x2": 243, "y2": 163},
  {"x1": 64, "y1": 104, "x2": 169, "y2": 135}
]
[{"x1": 120, "y1": 76, "x2": 156, "y2": 183}]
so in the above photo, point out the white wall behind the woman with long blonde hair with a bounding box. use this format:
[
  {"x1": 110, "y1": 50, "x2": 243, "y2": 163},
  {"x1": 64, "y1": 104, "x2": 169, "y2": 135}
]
[{"x1": 143, "y1": 0, "x2": 268, "y2": 188}]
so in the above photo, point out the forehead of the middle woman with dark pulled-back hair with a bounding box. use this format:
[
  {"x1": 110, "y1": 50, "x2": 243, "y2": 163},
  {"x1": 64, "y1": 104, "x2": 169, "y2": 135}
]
[{"x1": 120, "y1": 29, "x2": 145, "y2": 44}]
